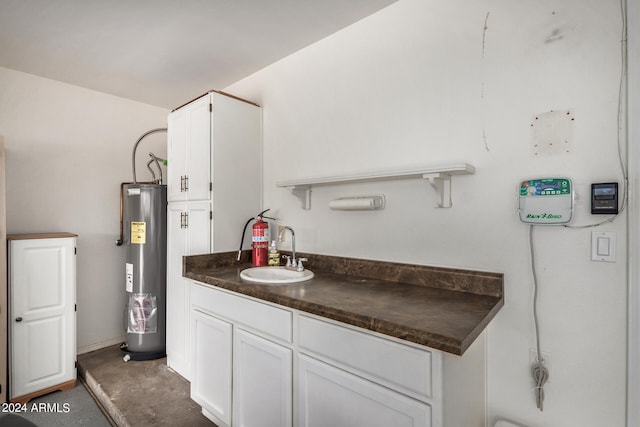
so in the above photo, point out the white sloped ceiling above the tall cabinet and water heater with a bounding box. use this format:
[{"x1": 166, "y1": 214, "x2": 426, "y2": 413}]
[{"x1": 0, "y1": 0, "x2": 397, "y2": 109}]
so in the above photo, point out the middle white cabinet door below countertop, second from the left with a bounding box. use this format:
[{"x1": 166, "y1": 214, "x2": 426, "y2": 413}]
[{"x1": 233, "y1": 329, "x2": 293, "y2": 427}]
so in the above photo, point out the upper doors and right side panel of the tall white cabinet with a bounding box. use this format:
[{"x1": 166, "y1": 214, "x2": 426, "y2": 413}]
[{"x1": 167, "y1": 92, "x2": 262, "y2": 252}]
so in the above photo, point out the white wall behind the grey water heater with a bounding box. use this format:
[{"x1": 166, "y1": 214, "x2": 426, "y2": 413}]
[{"x1": 0, "y1": 68, "x2": 168, "y2": 351}]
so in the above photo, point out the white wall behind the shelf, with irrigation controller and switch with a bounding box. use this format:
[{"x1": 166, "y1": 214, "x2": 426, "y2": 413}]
[{"x1": 225, "y1": 0, "x2": 626, "y2": 427}]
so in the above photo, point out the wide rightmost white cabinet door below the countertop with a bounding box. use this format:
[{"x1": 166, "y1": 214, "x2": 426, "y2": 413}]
[{"x1": 298, "y1": 355, "x2": 431, "y2": 427}]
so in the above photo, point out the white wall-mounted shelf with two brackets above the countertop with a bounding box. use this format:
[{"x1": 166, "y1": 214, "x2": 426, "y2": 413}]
[{"x1": 276, "y1": 163, "x2": 476, "y2": 210}]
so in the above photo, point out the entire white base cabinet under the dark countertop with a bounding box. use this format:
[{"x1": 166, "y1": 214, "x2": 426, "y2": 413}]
[{"x1": 191, "y1": 282, "x2": 485, "y2": 427}]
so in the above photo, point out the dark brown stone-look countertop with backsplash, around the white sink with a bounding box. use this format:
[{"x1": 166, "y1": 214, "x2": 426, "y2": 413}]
[{"x1": 183, "y1": 252, "x2": 504, "y2": 355}]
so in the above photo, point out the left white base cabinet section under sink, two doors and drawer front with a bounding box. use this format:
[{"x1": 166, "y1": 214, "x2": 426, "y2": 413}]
[{"x1": 191, "y1": 283, "x2": 293, "y2": 427}]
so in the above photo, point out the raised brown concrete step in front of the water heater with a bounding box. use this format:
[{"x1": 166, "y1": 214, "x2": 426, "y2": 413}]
[{"x1": 78, "y1": 346, "x2": 215, "y2": 427}]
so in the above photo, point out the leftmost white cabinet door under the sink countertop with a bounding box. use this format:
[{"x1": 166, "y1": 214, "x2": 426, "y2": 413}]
[{"x1": 191, "y1": 310, "x2": 233, "y2": 426}]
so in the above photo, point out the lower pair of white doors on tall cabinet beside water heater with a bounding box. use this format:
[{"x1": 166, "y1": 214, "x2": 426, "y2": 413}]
[{"x1": 167, "y1": 202, "x2": 211, "y2": 380}]
